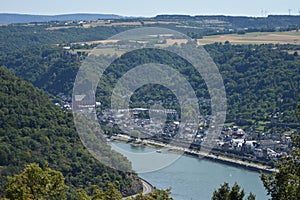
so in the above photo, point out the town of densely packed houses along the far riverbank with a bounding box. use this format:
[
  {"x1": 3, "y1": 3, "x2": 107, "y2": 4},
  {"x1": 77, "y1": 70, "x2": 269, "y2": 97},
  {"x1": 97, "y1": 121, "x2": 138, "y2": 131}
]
[{"x1": 98, "y1": 108, "x2": 292, "y2": 161}]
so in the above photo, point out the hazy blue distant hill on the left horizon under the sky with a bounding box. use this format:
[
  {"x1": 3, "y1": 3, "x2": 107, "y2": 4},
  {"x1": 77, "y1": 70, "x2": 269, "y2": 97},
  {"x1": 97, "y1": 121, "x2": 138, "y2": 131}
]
[{"x1": 0, "y1": 13, "x2": 124, "y2": 24}]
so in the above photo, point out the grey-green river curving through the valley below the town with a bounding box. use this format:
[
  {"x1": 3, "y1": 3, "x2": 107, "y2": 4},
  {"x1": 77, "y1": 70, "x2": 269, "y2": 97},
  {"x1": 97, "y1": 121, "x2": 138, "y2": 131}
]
[{"x1": 111, "y1": 142, "x2": 268, "y2": 200}]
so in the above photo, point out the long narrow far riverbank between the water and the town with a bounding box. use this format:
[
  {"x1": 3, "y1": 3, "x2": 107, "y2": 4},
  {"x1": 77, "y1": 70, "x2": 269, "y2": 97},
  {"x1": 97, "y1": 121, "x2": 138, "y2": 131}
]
[{"x1": 111, "y1": 135, "x2": 277, "y2": 173}]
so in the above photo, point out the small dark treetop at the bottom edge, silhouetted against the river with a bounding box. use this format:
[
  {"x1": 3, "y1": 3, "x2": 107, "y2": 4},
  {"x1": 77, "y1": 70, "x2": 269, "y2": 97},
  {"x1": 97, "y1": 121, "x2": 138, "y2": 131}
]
[{"x1": 212, "y1": 182, "x2": 255, "y2": 200}]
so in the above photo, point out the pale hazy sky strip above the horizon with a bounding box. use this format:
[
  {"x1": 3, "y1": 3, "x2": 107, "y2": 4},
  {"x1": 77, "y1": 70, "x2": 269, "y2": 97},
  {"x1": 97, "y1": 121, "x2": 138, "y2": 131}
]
[{"x1": 0, "y1": 0, "x2": 300, "y2": 16}]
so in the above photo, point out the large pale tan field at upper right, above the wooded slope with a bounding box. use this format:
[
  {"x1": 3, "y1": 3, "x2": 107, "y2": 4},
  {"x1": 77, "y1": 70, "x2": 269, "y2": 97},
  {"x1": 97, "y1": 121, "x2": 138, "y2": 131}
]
[{"x1": 198, "y1": 31, "x2": 300, "y2": 45}]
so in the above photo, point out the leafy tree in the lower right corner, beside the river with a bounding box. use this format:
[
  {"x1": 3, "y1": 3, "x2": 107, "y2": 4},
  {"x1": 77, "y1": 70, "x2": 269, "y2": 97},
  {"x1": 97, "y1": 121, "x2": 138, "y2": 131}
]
[{"x1": 261, "y1": 136, "x2": 300, "y2": 200}]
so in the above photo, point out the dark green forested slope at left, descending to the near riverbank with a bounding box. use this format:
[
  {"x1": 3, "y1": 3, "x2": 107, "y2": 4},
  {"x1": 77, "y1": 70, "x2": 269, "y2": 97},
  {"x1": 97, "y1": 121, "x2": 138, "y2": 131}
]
[{"x1": 0, "y1": 68, "x2": 140, "y2": 199}]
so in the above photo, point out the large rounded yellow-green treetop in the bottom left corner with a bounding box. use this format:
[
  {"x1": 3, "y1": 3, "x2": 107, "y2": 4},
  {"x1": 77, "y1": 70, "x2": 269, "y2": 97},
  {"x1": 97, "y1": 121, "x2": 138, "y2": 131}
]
[{"x1": 5, "y1": 163, "x2": 67, "y2": 200}]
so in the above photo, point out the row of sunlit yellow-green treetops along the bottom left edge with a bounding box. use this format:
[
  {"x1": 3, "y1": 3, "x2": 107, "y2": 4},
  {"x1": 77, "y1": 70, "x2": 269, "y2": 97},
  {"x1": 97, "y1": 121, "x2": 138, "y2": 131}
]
[{"x1": 5, "y1": 163, "x2": 172, "y2": 200}]
